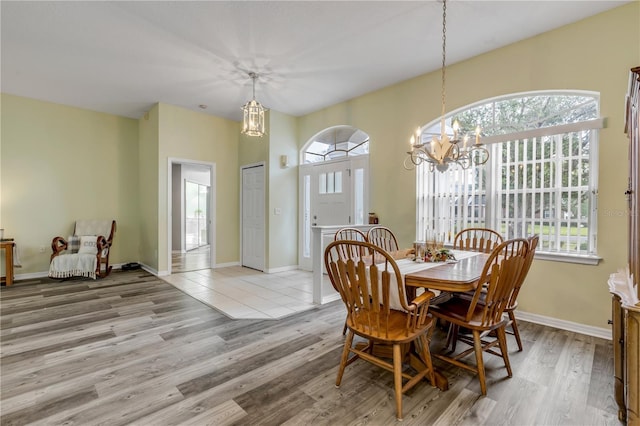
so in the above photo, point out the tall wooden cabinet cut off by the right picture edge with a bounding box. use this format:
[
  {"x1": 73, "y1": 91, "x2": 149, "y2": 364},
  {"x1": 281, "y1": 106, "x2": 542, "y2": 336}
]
[{"x1": 611, "y1": 67, "x2": 640, "y2": 426}]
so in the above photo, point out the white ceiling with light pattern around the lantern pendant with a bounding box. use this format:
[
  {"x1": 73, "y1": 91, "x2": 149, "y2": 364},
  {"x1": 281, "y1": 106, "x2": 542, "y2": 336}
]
[{"x1": 0, "y1": 0, "x2": 630, "y2": 121}]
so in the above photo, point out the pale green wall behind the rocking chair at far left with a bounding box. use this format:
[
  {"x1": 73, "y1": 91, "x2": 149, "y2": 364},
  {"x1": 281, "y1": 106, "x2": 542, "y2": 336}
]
[{"x1": 0, "y1": 94, "x2": 139, "y2": 274}]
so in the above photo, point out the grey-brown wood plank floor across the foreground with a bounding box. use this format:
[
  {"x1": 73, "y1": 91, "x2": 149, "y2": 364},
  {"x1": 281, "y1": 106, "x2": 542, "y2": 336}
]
[{"x1": 0, "y1": 270, "x2": 619, "y2": 425}]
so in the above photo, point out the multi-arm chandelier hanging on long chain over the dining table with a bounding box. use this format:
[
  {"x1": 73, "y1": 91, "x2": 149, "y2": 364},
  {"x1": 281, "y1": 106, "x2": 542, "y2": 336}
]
[{"x1": 404, "y1": 0, "x2": 489, "y2": 172}]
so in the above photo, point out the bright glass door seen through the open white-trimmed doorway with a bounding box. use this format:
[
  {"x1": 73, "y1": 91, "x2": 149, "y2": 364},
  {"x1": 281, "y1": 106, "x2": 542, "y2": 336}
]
[{"x1": 184, "y1": 181, "x2": 209, "y2": 251}]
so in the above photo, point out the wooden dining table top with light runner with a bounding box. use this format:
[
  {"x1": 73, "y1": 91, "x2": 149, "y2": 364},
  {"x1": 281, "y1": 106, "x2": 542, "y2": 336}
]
[{"x1": 404, "y1": 253, "x2": 489, "y2": 292}]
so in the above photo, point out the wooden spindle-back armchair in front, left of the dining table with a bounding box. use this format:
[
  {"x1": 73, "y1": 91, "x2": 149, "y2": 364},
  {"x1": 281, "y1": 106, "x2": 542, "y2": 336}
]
[{"x1": 324, "y1": 241, "x2": 435, "y2": 420}]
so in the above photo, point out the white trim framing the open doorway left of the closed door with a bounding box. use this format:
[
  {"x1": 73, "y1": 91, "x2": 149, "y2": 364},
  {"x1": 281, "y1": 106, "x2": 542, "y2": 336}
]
[{"x1": 167, "y1": 157, "x2": 217, "y2": 275}]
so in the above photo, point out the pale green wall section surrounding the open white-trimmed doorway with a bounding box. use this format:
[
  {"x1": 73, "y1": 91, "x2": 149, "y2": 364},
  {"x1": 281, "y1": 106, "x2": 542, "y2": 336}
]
[{"x1": 156, "y1": 104, "x2": 240, "y2": 272}]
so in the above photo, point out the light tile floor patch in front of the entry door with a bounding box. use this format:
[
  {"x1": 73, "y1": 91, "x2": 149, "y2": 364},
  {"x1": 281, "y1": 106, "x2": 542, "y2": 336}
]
[{"x1": 161, "y1": 266, "x2": 315, "y2": 319}]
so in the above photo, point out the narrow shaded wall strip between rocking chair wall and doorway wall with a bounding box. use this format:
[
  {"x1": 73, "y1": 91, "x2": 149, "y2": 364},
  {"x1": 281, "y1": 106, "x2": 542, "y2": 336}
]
[{"x1": 138, "y1": 105, "x2": 160, "y2": 271}]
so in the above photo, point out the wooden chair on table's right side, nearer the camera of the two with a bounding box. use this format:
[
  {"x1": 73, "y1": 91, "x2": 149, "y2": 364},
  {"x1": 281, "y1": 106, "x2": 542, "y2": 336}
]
[{"x1": 431, "y1": 238, "x2": 529, "y2": 395}]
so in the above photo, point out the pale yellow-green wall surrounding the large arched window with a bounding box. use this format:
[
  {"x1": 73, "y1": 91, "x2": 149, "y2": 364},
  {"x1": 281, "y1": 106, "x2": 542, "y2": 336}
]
[{"x1": 298, "y1": 2, "x2": 640, "y2": 328}]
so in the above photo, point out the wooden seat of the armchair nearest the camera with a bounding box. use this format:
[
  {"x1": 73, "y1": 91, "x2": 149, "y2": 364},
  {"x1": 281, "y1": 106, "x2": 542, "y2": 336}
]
[{"x1": 347, "y1": 309, "x2": 433, "y2": 344}]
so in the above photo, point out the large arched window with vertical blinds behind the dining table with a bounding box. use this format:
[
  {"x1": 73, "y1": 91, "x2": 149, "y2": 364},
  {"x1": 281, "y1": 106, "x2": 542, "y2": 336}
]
[{"x1": 416, "y1": 91, "x2": 603, "y2": 263}]
